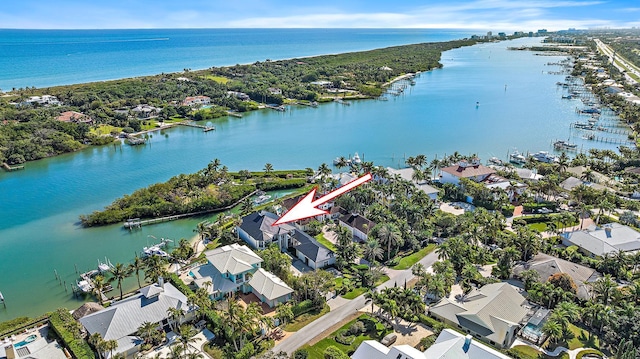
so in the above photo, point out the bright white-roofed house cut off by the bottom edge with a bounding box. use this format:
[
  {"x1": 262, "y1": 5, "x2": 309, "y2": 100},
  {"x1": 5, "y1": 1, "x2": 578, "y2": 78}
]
[{"x1": 351, "y1": 329, "x2": 509, "y2": 359}]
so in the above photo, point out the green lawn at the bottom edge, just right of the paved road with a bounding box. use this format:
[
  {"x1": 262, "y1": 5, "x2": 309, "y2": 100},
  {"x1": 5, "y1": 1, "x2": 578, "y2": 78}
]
[{"x1": 302, "y1": 314, "x2": 391, "y2": 359}]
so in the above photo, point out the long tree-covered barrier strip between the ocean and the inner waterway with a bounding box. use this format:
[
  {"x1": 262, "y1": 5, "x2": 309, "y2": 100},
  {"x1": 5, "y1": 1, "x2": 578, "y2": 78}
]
[{"x1": 0, "y1": 40, "x2": 484, "y2": 164}]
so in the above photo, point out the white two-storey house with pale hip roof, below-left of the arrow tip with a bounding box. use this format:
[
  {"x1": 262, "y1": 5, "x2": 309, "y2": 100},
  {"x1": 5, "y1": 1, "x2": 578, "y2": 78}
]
[{"x1": 189, "y1": 243, "x2": 293, "y2": 307}]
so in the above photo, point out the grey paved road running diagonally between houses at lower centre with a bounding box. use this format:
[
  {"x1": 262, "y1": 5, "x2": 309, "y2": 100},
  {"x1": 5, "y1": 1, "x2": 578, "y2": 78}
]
[{"x1": 272, "y1": 251, "x2": 438, "y2": 354}]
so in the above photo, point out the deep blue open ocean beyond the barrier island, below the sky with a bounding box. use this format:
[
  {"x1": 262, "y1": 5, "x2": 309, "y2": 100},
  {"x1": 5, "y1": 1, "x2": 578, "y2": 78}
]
[{"x1": 0, "y1": 29, "x2": 473, "y2": 91}]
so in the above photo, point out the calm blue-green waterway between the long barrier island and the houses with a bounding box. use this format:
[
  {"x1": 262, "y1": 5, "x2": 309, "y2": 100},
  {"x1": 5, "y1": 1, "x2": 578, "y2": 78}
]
[{"x1": 0, "y1": 30, "x2": 632, "y2": 321}]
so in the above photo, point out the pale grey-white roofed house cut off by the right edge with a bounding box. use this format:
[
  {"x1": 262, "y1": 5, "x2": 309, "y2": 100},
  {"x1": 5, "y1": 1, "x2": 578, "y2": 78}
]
[{"x1": 562, "y1": 223, "x2": 640, "y2": 257}]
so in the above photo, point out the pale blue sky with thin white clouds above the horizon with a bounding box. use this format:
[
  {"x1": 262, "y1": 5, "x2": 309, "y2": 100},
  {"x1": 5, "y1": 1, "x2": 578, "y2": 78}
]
[{"x1": 0, "y1": 0, "x2": 640, "y2": 31}]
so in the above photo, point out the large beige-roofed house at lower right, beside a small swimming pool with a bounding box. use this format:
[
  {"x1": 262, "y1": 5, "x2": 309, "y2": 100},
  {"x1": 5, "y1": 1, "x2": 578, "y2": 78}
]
[{"x1": 429, "y1": 283, "x2": 528, "y2": 348}]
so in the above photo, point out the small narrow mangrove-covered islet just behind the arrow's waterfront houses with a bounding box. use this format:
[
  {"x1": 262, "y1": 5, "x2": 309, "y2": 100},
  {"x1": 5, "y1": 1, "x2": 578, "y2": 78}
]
[{"x1": 80, "y1": 159, "x2": 307, "y2": 226}]
